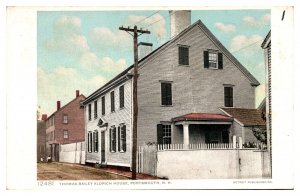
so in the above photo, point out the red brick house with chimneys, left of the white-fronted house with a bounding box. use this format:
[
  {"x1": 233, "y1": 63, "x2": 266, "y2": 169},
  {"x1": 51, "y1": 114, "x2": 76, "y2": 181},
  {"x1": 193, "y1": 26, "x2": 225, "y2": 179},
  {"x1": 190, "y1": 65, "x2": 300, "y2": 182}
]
[{"x1": 46, "y1": 90, "x2": 85, "y2": 161}]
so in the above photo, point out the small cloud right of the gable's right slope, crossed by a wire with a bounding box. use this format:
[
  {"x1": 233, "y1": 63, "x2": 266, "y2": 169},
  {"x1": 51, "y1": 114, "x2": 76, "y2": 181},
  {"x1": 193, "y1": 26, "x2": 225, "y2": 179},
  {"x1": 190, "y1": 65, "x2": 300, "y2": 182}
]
[{"x1": 229, "y1": 35, "x2": 263, "y2": 53}]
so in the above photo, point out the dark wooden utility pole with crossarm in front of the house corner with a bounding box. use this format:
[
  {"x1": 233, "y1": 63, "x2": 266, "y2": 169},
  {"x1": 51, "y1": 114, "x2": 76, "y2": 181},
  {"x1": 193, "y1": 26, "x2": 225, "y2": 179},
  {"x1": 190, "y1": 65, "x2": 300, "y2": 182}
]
[{"x1": 119, "y1": 25, "x2": 150, "y2": 180}]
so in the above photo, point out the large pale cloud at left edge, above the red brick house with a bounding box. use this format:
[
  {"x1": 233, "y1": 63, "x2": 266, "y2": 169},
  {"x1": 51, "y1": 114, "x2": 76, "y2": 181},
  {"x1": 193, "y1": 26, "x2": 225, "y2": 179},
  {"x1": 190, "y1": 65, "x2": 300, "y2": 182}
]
[{"x1": 37, "y1": 65, "x2": 107, "y2": 115}]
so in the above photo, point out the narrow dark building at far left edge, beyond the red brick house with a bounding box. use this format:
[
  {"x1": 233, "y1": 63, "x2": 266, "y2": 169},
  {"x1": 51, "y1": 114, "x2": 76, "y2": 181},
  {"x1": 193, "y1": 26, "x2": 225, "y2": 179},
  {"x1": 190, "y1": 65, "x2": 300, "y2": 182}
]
[{"x1": 36, "y1": 114, "x2": 47, "y2": 162}]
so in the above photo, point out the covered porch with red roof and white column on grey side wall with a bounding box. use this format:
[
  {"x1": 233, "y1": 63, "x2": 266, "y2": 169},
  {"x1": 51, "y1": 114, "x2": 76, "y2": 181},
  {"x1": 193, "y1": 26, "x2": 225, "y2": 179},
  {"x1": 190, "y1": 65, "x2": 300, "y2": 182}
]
[{"x1": 172, "y1": 113, "x2": 233, "y2": 148}]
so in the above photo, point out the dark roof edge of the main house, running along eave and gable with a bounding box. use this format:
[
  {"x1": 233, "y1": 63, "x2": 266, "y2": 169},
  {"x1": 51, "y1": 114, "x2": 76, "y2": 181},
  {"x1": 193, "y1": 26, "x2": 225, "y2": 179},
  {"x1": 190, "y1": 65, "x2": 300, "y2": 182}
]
[{"x1": 82, "y1": 20, "x2": 259, "y2": 105}]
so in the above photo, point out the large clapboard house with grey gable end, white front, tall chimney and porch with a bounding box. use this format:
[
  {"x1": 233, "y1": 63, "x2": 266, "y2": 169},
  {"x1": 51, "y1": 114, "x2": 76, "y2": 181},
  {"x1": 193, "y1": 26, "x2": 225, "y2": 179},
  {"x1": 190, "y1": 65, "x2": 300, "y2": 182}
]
[{"x1": 83, "y1": 11, "x2": 259, "y2": 166}]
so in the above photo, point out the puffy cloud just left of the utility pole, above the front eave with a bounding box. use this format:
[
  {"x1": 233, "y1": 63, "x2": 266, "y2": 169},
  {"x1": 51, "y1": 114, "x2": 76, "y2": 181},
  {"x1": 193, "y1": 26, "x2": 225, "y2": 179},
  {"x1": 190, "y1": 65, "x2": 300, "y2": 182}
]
[{"x1": 80, "y1": 52, "x2": 128, "y2": 75}]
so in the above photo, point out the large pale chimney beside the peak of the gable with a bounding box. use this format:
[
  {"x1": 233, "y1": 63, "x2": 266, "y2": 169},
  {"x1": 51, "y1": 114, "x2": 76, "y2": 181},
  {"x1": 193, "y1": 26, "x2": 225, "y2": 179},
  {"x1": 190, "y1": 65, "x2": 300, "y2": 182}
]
[{"x1": 169, "y1": 10, "x2": 191, "y2": 38}]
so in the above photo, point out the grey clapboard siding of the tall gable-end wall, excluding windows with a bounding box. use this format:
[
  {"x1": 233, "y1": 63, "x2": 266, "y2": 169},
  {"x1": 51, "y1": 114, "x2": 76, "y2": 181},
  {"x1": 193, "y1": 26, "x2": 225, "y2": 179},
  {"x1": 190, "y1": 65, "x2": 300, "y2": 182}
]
[{"x1": 138, "y1": 23, "x2": 255, "y2": 145}]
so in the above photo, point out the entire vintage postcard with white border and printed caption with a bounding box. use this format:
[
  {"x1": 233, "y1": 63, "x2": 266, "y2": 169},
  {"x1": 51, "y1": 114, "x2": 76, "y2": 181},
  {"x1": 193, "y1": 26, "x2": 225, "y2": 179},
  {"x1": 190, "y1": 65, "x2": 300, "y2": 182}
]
[{"x1": 6, "y1": 2, "x2": 294, "y2": 190}]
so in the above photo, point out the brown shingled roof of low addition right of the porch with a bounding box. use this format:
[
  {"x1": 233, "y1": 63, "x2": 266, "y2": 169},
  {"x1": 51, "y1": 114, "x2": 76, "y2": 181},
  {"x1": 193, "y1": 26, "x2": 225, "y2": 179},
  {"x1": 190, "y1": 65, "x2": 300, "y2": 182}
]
[{"x1": 220, "y1": 108, "x2": 266, "y2": 127}]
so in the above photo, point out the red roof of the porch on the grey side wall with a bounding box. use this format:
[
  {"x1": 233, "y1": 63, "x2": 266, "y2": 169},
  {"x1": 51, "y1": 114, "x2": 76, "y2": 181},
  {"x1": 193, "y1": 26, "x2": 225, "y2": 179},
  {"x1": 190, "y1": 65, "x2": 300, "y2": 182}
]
[{"x1": 172, "y1": 113, "x2": 233, "y2": 122}]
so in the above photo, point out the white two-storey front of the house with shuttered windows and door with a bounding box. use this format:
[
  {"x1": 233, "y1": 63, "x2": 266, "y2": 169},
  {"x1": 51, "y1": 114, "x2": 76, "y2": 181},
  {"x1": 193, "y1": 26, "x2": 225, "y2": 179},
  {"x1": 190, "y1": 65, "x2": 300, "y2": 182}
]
[{"x1": 83, "y1": 77, "x2": 132, "y2": 167}]
